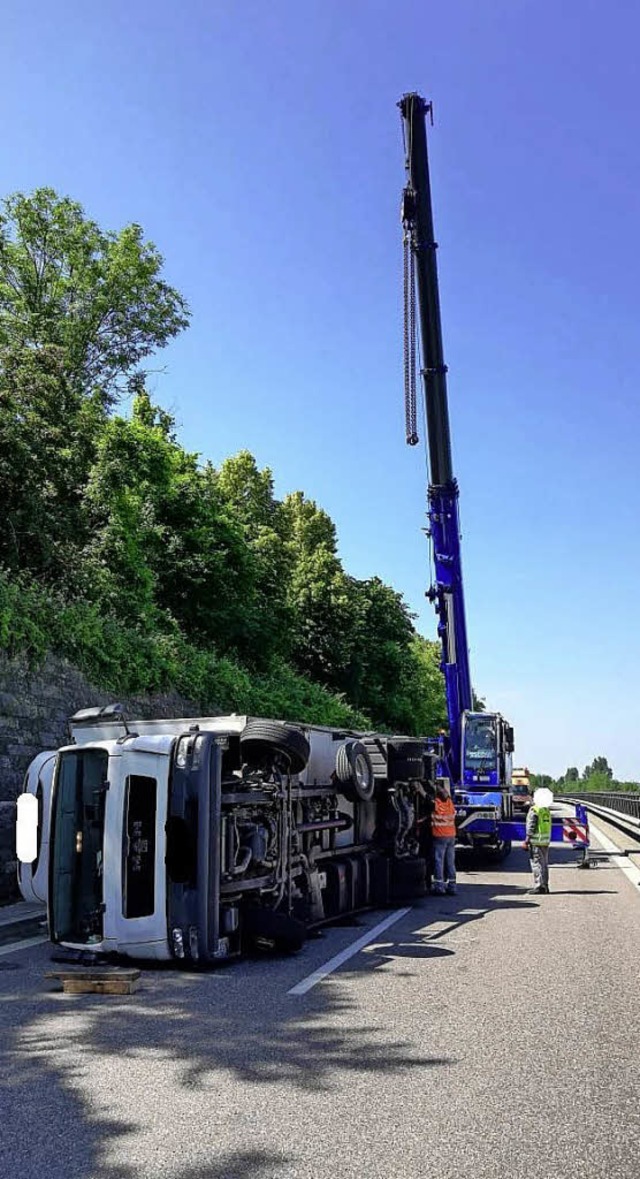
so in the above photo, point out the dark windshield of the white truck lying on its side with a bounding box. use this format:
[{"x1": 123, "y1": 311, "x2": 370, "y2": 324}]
[{"x1": 50, "y1": 749, "x2": 108, "y2": 942}]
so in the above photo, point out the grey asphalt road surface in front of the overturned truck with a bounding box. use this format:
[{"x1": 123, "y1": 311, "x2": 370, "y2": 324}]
[{"x1": 0, "y1": 820, "x2": 640, "y2": 1179}]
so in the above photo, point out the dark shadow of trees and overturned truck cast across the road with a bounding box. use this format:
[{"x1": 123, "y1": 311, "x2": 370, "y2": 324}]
[{"x1": 0, "y1": 849, "x2": 608, "y2": 1179}]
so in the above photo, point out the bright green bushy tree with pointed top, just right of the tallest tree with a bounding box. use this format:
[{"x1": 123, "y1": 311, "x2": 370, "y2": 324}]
[{"x1": 85, "y1": 390, "x2": 256, "y2": 651}]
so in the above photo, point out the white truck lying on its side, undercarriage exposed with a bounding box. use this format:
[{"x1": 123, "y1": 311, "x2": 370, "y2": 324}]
[{"x1": 21, "y1": 705, "x2": 436, "y2": 964}]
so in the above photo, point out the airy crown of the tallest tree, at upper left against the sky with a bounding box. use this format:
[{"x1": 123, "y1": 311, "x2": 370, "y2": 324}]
[{"x1": 0, "y1": 187, "x2": 189, "y2": 404}]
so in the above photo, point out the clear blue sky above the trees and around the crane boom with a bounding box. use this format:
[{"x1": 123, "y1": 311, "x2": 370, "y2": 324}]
[{"x1": 0, "y1": 0, "x2": 640, "y2": 778}]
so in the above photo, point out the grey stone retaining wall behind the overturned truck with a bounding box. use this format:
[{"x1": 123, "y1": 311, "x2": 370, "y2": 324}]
[{"x1": 0, "y1": 652, "x2": 200, "y2": 903}]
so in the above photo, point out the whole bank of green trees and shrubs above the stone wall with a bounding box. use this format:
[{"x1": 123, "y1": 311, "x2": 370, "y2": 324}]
[{"x1": 0, "y1": 189, "x2": 447, "y2": 733}]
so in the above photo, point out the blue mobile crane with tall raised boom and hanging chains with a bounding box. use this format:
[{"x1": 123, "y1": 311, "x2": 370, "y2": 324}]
[{"x1": 398, "y1": 93, "x2": 588, "y2": 858}]
